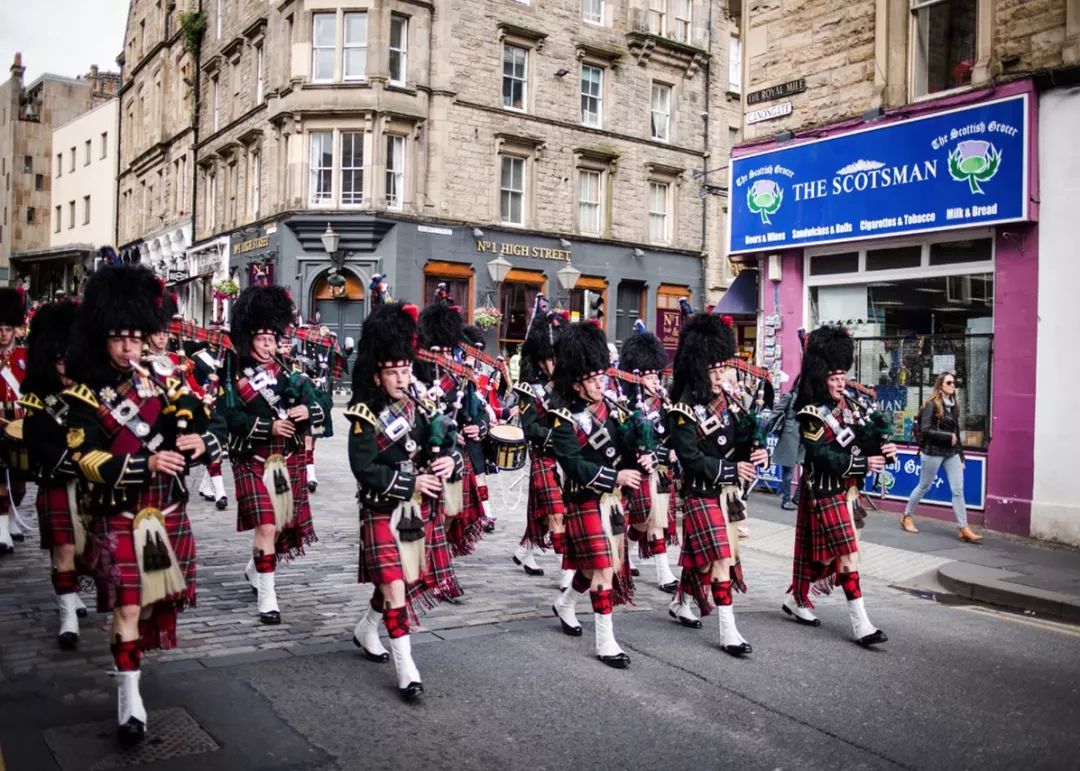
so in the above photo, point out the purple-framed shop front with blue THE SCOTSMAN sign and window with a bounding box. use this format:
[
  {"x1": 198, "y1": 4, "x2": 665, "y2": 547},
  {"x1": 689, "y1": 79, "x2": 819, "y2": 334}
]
[{"x1": 729, "y1": 83, "x2": 1039, "y2": 535}]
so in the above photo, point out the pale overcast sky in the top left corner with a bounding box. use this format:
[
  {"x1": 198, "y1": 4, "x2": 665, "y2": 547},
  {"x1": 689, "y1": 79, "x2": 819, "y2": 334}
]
[{"x1": 0, "y1": 0, "x2": 129, "y2": 83}]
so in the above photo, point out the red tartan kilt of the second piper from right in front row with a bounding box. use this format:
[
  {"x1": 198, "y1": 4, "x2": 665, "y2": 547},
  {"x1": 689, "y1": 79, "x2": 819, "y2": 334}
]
[{"x1": 672, "y1": 493, "x2": 746, "y2": 616}]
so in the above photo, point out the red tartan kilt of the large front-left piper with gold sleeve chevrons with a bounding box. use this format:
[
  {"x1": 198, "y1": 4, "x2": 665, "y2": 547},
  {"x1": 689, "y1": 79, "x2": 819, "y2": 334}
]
[{"x1": 85, "y1": 474, "x2": 195, "y2": 650}]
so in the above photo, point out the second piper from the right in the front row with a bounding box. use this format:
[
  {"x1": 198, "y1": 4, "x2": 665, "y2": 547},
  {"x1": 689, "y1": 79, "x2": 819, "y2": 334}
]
[{"x1": 667, "y1": 313, "x2": 769, "y2": 657}]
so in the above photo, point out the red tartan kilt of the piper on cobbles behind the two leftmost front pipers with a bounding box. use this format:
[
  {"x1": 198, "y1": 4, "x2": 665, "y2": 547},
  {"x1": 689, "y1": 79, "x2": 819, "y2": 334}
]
[{"x1": 231, "y1": 436, "x2": 319, "y2": 560}]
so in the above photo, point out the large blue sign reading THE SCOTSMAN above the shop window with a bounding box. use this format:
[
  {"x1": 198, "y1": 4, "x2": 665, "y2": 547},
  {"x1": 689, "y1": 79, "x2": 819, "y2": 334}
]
[{"x1": 728, "y1": 94, "x2": 1029, "y2": 254}]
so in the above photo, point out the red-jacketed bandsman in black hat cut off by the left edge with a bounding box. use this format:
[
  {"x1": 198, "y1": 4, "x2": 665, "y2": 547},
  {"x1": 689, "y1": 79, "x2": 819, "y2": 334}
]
[{"x1": 0, "y1": 286, "x2": 26, "y2": 554}]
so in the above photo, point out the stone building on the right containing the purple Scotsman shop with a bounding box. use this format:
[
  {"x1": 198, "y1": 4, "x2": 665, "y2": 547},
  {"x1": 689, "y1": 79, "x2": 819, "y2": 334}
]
[{"x1": 721, "y1": 0, "x2": 1080, "y2": 543}]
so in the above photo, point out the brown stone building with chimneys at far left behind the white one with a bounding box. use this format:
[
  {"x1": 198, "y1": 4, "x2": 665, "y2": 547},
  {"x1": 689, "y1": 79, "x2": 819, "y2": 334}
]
[{"x1": 0, "y1": 53, "x2": 118, "y2": 282}]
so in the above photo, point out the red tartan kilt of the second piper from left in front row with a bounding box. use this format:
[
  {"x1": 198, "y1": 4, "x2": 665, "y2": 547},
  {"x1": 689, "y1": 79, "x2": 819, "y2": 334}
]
[{"x1": 357, "y1": 500, "x2": 461, "y2": 623}]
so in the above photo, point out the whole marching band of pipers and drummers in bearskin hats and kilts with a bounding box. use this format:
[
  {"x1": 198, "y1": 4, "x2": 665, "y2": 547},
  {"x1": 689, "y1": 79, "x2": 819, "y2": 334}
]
[{"x1": 0, "y1": 266, "x2": 895, "y2": 744}]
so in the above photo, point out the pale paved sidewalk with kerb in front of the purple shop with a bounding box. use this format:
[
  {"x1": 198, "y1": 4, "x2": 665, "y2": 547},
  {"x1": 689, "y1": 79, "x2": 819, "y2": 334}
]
[{"x1": 743, "y1": 492, "x2": 1080, "y2": 623}]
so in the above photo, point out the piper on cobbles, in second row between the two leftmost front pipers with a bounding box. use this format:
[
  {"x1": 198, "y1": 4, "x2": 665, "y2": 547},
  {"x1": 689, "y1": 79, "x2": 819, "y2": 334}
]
[{"x1": 218, "y1": 286, "x2": 326, "y2": 624}]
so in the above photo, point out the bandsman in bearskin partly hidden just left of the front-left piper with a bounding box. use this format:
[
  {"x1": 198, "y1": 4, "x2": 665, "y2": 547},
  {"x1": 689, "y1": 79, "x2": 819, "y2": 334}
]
[{"x1": 19, "y1": 302, "x2": 87, "y2": 650}]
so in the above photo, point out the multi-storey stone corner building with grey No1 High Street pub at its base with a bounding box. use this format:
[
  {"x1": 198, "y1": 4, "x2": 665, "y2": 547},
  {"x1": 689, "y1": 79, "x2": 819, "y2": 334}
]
[{"x1": 168, "y1": 0, "x2": 729, "y2": 348}]
